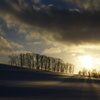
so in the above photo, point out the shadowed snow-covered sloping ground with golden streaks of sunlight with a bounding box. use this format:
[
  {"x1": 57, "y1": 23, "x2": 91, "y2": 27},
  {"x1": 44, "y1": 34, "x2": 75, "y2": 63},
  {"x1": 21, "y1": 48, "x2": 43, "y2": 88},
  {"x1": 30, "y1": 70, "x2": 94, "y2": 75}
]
[{"x1": 0, "y1": 64, "x2": 100, "y2": 100}]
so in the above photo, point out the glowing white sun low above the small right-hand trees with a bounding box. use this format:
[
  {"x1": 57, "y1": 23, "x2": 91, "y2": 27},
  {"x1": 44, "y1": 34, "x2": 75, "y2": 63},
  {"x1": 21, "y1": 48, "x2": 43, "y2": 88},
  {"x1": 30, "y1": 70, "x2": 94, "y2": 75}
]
[{"x1": 78, "y1": 55, "x2": 93, "y2": 70}]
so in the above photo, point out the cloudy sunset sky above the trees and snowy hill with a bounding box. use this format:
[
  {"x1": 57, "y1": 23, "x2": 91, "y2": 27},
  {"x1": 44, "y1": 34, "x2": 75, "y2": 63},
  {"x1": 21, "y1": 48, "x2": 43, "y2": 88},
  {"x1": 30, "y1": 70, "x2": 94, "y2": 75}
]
[{"x1": 0, "y1": 0, "x2": 100, "y2": 72}]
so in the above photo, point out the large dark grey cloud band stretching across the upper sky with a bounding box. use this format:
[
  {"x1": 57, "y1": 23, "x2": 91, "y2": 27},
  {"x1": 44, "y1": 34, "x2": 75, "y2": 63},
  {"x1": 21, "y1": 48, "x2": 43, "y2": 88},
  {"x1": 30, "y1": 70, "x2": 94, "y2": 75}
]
[{"x1": 0, "y1": 0, "x2": 100, "y2": 44}]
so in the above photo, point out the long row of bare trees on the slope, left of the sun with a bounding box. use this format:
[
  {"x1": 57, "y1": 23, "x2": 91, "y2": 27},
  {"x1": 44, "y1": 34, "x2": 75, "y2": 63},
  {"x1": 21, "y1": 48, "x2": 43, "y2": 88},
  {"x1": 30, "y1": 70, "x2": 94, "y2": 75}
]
[{"x1": 9, "y1": 53, "x2": 74, "y2": 73}]
